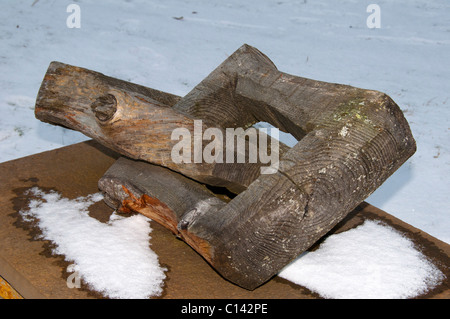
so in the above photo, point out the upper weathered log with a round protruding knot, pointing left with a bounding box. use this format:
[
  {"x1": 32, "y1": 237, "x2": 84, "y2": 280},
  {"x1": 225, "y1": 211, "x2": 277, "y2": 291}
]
[{"x1": 35, "y1": 62, "x2": 289, "y2": 193}]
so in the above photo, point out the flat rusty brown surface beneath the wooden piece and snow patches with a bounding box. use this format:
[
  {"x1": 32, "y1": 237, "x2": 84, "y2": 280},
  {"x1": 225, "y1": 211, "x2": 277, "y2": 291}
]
[{"x1": 0, "y1": 141, "x2": 450, "y2": 299}]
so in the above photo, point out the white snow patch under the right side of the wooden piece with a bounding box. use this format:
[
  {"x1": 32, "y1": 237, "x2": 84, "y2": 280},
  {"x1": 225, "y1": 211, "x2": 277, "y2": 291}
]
[{"x1": 279, "y1": 221, "x2": 445, "y2": 299}]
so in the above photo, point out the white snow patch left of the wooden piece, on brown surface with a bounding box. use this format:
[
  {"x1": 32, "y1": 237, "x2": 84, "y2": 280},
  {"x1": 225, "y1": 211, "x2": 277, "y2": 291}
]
[{"x1": 20, "y1": 188, "x2": 166, "y2": 299}]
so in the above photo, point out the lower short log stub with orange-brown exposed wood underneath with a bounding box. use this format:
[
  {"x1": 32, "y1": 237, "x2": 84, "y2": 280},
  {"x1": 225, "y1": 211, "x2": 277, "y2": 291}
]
[{"x1": 98, "y1": 157, "x2": 230, "y2": 267}]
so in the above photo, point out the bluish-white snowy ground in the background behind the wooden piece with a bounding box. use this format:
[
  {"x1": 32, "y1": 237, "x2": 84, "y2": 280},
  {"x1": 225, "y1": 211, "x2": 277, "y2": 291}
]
[{"x1": 0, "y1": 0, "x2": 450, "y2": 248}]
